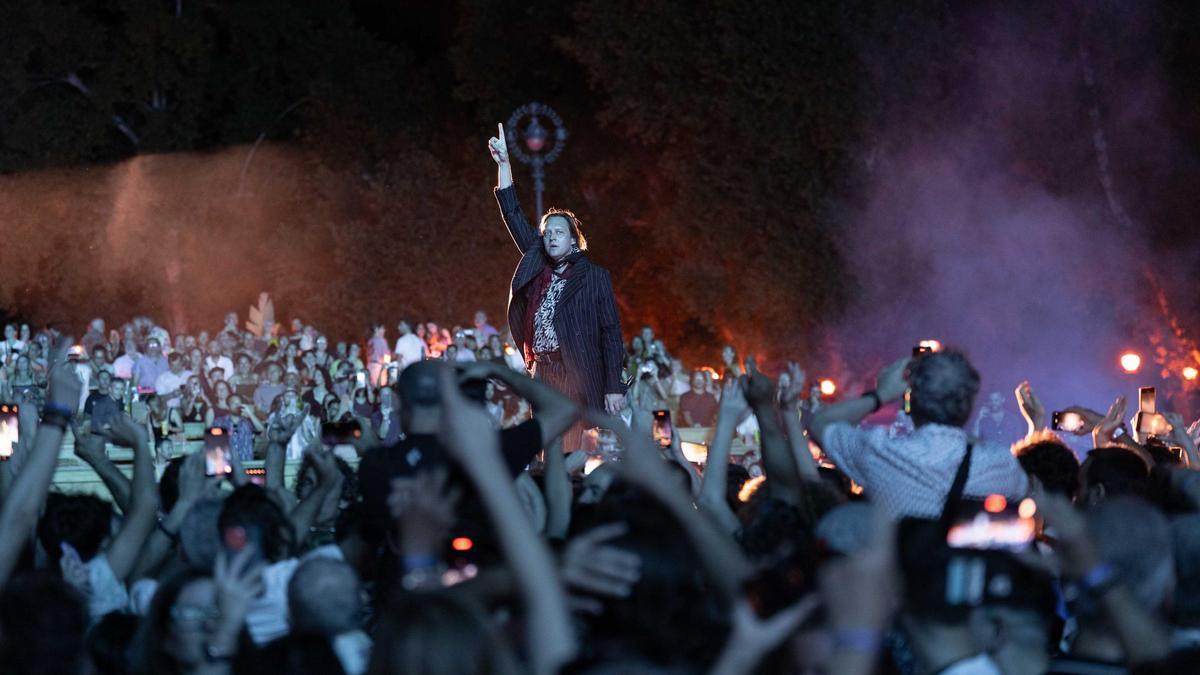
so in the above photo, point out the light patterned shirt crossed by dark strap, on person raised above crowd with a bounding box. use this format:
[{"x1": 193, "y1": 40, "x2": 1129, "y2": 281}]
[{"x1": 821, "y1": 422, "x2": 1030, "y2": 518}]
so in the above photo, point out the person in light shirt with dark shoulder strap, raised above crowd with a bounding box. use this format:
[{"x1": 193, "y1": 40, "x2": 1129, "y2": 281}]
[{"x1": 810, "y1": 350, "x2": 1028, "y2": 518}]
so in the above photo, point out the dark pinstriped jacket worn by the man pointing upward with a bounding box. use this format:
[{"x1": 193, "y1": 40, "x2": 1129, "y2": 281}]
[{"x1": 496, "y1": 187, "x2": 625, "y2": 410}]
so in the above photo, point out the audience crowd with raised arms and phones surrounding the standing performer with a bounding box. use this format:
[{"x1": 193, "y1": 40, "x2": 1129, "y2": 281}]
[{"x1": 0, "y1": 312, "x2": 1200, "y2": 675}]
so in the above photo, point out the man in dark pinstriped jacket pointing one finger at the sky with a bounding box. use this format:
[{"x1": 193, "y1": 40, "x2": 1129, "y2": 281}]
[{"x1": 488, "y1": 125, "x2": 625, "y2": 420}]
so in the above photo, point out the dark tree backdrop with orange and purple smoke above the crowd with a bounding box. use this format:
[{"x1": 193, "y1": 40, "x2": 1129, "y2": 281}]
[{"x1": 0, "y1": 0, "x2": 1200, "y2": 387}]
